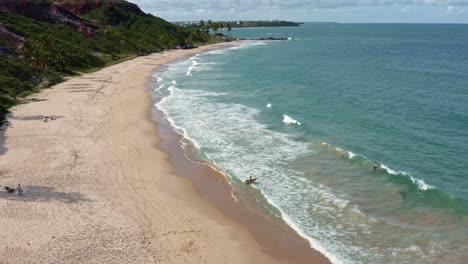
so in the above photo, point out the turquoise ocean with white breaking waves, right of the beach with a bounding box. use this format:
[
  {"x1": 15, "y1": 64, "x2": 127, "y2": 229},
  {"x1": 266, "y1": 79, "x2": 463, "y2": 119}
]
[{"x1": 153, "y1": 24, "x2": 468, "y2": 263}]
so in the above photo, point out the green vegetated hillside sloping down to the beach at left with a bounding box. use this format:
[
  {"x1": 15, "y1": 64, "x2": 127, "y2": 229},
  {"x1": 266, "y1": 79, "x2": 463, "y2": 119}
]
[{"x1": 0, "y1": 0, "x2": 227, "y2": 119}]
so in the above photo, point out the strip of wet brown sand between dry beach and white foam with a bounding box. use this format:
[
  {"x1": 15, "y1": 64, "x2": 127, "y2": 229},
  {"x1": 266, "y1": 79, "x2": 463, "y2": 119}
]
[{"x1": 148, "y1": 64, "x2": 330, "y2": 263}]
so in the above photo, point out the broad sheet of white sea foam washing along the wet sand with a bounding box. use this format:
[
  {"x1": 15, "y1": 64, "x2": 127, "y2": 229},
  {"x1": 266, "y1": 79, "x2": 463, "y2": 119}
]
[{"x1": 157, "y1": 86, "x2": 366, "y2": 263}]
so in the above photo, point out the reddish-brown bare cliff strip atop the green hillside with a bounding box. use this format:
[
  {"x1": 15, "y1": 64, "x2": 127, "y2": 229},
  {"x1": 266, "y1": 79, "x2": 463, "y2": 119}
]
[{"x1": 0, "y1": 0, "x2": 94, "y2": 35}]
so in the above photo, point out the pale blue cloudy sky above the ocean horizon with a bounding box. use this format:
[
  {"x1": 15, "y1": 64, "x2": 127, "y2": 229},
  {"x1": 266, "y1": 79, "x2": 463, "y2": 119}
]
[{"x1": 129, "y1": 0, "x2": 468, "y2": 23}]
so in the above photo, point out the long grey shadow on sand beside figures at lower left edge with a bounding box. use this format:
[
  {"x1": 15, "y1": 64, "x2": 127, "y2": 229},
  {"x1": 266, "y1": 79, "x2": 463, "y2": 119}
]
[{"x1": 0, "y1": 186, "x2": 91, "y2": 203}]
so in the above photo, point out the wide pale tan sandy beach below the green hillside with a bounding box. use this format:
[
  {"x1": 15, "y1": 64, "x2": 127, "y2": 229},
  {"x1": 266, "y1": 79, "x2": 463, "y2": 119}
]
[{"x1": 0, "y1": 44, "x2": 328, "y2": 263}]
